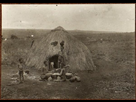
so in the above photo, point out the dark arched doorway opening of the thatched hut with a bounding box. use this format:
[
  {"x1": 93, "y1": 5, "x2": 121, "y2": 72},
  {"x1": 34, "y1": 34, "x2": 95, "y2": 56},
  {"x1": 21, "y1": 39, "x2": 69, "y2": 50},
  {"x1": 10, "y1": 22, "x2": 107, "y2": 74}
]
[{"x1": 49, "y1": 55, "x2": 59, "y2": 70}]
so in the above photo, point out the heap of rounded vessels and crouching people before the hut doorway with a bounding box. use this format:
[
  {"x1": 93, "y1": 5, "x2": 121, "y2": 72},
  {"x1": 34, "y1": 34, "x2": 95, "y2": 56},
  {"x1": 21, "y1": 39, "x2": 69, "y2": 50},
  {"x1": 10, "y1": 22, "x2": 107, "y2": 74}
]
[{"x1": 40, "y1": 60, "x2": 81, "y2": 82}]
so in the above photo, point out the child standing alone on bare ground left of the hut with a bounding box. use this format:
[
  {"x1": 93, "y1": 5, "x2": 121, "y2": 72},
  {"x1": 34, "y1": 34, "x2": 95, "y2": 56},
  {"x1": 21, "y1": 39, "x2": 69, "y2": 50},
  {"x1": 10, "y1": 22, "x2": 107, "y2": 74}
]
[{"x1": 18, "y1": 58, "x2": 25, "y2": 83}]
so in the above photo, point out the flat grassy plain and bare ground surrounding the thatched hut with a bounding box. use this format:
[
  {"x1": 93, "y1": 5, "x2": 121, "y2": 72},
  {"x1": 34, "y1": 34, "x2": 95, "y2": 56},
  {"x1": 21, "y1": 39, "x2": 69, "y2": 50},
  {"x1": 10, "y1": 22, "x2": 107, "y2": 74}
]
[{"x1": 1, "y1": 29, "x2": 135, "y2": 99}]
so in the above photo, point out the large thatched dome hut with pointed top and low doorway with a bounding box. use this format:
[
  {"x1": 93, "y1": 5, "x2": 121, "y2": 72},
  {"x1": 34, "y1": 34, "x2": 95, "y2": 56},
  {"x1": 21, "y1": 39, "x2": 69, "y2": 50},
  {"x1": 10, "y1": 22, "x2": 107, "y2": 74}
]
[{"x1": 26, "y1": 26, "x2": 95, "y2": 70}]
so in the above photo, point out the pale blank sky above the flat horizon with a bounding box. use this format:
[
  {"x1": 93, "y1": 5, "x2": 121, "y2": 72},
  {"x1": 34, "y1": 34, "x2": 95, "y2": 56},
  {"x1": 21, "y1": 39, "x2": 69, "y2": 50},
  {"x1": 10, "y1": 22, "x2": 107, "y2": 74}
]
[{"x1": 2, "y1": 4, "x2": 135, "y2": 32}]
